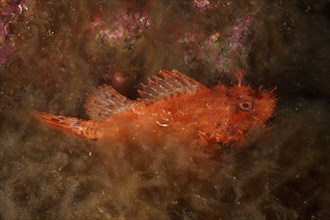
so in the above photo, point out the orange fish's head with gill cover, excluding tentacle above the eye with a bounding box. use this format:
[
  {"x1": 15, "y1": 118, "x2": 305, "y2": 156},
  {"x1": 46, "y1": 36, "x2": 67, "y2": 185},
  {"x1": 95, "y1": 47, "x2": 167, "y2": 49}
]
[{"x1": 197, "y1": 81, "x2": 276, "y2": 144}]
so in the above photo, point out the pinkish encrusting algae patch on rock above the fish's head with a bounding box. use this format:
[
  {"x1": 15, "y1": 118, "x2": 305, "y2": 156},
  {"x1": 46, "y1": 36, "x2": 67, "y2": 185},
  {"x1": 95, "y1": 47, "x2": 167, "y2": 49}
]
[{"x1": 177, "y1": 14, "x2": 254, "y2": 78}]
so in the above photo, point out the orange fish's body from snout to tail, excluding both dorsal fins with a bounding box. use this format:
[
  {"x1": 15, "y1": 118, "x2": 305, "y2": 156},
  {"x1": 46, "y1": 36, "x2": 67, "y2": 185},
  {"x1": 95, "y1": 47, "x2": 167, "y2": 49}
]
[{"x1": 36, "y1": 72, "x2": 276, "y2": 144}]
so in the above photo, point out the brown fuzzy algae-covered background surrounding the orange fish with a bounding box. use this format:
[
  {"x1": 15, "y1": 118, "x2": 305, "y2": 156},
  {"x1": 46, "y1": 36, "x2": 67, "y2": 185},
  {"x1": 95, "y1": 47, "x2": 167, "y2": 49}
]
[{"x1": 0, "y1": 0, "x2": 330, "y2": 219}]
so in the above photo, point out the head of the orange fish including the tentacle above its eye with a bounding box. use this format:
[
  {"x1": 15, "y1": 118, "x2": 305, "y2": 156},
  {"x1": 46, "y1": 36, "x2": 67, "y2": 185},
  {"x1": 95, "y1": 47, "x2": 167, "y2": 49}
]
[{"x1": 213, "y1": 70, "x2": 276, "y2": 144}]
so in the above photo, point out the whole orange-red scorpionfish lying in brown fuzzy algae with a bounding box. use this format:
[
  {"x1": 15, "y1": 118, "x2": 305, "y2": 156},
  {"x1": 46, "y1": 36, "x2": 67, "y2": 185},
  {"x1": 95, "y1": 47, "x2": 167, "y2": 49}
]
[{"x1": 33, "y1": 70, "x2": 277, "y2": 144}]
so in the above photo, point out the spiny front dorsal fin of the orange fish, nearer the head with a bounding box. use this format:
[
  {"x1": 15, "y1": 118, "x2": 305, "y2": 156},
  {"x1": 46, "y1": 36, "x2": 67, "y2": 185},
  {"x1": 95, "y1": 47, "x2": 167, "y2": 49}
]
[{"x1": 138, "y1": 70, "x2": 205, "y2": 101}]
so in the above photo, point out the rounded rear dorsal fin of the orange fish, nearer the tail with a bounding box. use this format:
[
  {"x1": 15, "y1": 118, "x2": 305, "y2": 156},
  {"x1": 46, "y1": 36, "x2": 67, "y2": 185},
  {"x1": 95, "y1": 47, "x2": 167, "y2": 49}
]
[{"x1": 85, "y1": 85, "x2": 134, "y2": 120}]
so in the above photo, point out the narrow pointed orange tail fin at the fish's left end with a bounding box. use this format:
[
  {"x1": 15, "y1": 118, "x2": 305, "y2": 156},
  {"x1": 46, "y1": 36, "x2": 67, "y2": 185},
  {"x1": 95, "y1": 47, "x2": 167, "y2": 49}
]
[{"x1": 32, "y1": 111, "x2": 97, "y2": 139}]
